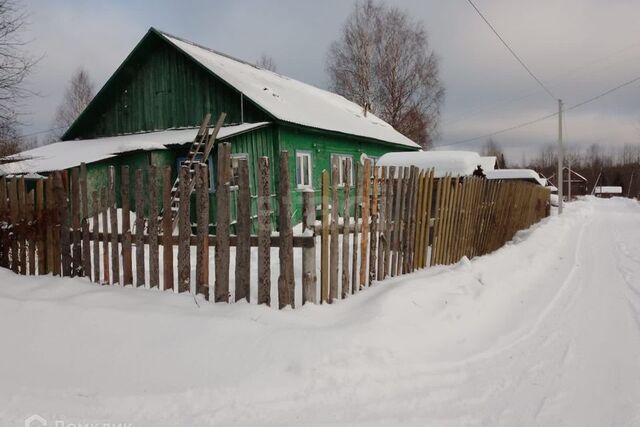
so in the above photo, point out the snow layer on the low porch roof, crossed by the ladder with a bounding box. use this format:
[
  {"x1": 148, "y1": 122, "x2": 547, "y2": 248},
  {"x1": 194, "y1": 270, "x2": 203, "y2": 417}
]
[{"x1": 0, "y1": 122, "x2": 269, "y2": 175}]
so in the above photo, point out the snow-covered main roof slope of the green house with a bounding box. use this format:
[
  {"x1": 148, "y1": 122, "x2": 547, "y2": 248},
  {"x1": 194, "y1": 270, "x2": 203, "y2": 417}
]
[{"x1": 158, "y1": 31, "x2": 419, "y2": 148}]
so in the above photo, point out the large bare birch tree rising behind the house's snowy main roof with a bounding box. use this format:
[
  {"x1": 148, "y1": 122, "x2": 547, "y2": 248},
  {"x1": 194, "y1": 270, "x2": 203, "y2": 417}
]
[{"x1": 327, "y1": 0, "x2": 444, "y2": 148}]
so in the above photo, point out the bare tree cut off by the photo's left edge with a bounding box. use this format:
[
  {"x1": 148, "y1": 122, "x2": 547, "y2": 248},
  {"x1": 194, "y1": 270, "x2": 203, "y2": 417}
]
[{"x1": 0, "y1": 0, "x2": 37, "y2": 157}]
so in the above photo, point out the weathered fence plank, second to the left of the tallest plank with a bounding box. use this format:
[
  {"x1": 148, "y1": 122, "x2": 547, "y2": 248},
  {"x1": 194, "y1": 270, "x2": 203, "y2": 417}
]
[{"x1": 178, "y1": 165, "x2": 190, "y2": 293}]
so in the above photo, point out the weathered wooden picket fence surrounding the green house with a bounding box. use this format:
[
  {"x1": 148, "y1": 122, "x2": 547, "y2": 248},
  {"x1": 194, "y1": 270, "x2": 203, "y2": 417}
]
[{"x1": 0, "y1": 149, "x2": 549, "y2": 308}]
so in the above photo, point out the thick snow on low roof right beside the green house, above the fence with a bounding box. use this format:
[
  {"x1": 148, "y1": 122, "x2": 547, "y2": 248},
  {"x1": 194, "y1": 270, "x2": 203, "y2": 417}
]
[{"x1": 377, "y1": 151, "x2": 495, "y2": 178}]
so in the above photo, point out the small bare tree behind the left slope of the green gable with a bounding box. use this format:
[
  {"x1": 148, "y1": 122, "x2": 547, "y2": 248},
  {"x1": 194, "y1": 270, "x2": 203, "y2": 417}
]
[{"x1": 49, "y1": 68, "x2": 94, "y2": 142}]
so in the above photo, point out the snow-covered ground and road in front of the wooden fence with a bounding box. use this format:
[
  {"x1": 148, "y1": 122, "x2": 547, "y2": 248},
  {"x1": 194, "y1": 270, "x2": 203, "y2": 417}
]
[{"x1": 0, "y1": 199, "x2": 640, "y2": 427}]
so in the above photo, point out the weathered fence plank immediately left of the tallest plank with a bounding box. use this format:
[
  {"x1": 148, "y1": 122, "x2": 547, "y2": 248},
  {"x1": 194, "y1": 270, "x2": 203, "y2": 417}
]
[{"x1": 196, "y1": 163, "x2": 210, "y2": 300}]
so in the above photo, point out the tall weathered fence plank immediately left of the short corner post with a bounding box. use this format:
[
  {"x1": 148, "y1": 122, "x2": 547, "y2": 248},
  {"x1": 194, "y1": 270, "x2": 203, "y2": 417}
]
[{"x1": 278, "y1": 151, "x2": 295, "y2": 308}]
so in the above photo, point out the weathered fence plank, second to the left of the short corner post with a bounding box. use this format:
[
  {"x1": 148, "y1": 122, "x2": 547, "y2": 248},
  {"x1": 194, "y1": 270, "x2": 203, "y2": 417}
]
[{"x1": 258, "y1": 157, "x2": 271, "y2": 305}]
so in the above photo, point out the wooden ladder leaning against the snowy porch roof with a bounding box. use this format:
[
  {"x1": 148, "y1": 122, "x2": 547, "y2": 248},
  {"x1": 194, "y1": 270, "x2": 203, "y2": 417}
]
[{"x1": 162, "y1": 113, "x2": 227, "y2": 230}]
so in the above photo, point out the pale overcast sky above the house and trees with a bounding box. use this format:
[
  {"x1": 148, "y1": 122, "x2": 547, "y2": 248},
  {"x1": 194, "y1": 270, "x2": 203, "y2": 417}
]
[{"x1": 18, "y1": 0, "x2": 640, "y2": 161}]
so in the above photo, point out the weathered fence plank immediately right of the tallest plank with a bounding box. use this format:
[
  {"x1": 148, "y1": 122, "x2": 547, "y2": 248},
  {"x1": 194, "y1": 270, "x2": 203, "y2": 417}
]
[{"x1": 235, "y1": 158, "x2": 251, "y2": 302}]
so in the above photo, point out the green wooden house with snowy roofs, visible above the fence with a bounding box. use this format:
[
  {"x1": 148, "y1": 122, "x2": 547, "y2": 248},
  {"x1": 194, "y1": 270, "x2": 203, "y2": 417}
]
[{"x1": 0, "y1": 28, "x2": 420, "y2": 224}]
